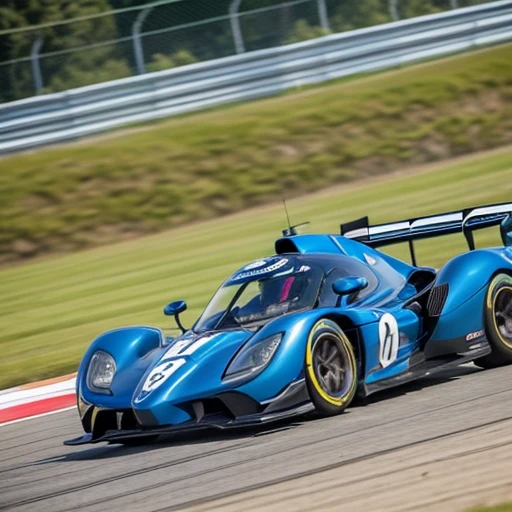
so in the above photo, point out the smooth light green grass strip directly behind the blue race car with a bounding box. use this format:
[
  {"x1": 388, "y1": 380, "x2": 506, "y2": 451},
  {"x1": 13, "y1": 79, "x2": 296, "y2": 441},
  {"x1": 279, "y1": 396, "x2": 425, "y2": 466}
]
[{"x1": 0, "y1": 147, "x2": 512, "y2": 388}]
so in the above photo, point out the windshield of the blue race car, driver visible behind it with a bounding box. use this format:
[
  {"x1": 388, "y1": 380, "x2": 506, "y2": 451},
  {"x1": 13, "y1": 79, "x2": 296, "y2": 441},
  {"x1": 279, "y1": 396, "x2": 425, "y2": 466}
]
[{"x1": 193, "y1": 265, "x2": 323, "y2": 332}]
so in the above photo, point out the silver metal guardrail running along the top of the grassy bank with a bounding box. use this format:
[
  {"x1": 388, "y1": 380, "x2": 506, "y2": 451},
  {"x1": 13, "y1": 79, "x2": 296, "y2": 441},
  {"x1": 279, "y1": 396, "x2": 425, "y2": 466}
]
[{"x1": 0, "y1": 0, "x2": 512, "y2": 153}]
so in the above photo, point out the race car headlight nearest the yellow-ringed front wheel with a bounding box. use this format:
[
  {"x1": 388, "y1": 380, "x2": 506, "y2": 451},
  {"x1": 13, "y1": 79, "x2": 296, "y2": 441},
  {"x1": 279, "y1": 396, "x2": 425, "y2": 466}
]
[{"x1": 224, "y1": 332, "x2": 284, "y2": 379}]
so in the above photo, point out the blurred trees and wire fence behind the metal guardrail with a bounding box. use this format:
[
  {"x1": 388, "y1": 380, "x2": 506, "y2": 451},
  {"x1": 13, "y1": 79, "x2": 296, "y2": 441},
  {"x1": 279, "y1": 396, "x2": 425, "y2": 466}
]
[{"x1": 0, "y1": 0, "x2": 496, "y2": 102}]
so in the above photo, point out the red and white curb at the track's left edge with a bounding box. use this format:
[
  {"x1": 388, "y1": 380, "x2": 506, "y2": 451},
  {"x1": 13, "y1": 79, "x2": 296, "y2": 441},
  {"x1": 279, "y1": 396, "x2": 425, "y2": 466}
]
[{"x1": 0, "y1": 375, "x2": 76, "y2": 427}]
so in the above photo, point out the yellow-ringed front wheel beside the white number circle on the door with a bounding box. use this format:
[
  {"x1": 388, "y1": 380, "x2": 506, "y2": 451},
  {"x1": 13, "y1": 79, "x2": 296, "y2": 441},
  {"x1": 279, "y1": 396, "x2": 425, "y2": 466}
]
[{"x1": 304, "y1": 319, "x2": 357, "y2": 416}]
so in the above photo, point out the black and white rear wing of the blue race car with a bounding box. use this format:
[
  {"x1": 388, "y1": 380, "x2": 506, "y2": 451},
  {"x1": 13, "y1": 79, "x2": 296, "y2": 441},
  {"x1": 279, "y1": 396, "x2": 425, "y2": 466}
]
[{"x1": 340, "y1": 203, "x2": 512, "y2": 266}]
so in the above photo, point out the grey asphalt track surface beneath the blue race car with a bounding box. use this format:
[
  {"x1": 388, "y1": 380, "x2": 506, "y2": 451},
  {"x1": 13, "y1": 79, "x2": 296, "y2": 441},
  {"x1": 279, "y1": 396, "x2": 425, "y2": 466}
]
[{"x1": 0, "y1": 365, "x2": 512, "y2": 512}]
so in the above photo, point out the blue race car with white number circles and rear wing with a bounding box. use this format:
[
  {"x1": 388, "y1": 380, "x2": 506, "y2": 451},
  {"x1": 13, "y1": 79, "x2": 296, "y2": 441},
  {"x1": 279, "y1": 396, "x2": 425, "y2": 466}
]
[{"x1": 67, "y1": 203, "x2": 512, "y2": 445}]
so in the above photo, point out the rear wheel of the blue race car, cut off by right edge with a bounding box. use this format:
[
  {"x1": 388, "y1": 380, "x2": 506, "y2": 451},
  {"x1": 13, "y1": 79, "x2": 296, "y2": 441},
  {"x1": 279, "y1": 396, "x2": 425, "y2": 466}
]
[{"x1": 474, "y1": 274, "x2": 512, "y2": 368}]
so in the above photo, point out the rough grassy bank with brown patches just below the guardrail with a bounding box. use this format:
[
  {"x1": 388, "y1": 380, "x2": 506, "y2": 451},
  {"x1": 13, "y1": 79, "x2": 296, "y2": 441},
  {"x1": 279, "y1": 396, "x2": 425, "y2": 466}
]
[{"x1": 0, "y1": 45, "x2": 512, "y2": 262}]
